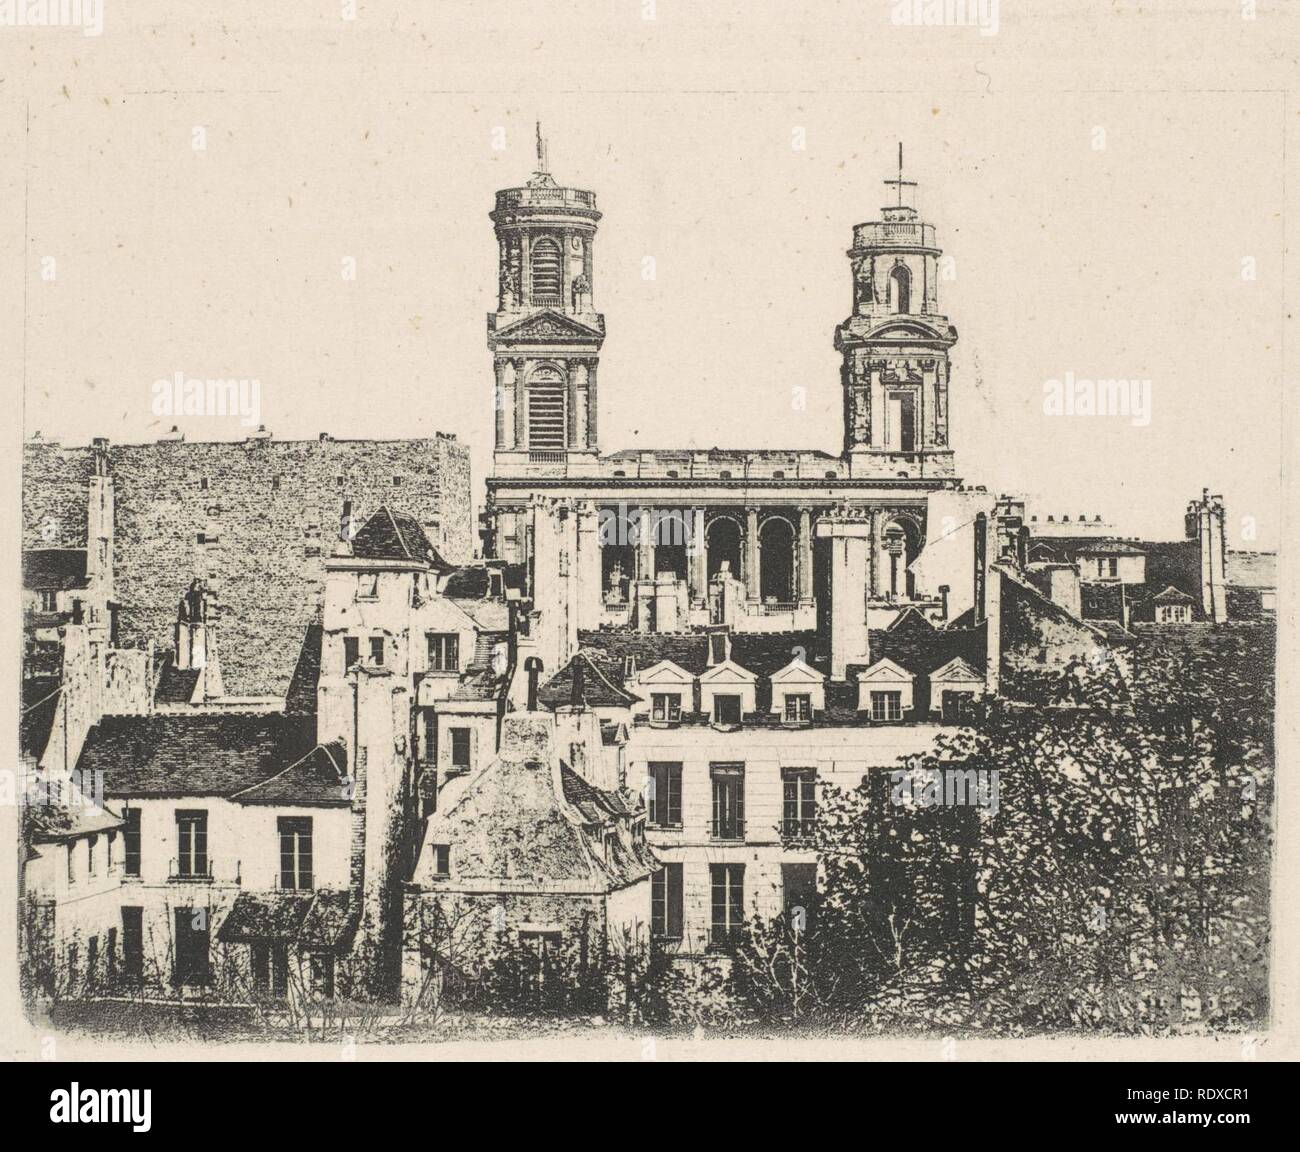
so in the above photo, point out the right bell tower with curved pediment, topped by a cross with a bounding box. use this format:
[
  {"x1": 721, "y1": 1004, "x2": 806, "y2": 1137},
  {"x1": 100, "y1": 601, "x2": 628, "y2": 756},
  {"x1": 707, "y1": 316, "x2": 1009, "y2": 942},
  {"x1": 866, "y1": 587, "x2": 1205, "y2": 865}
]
[{"x1": 835, "y1": 144, "x2": 957, "y2": 480}]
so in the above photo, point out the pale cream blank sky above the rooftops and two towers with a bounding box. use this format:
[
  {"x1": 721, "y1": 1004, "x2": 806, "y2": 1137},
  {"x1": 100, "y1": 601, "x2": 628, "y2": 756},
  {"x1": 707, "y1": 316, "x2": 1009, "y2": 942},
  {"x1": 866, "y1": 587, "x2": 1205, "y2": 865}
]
[{"x1": 0, "y1": 3, "x2": 1295, "y2": 547}]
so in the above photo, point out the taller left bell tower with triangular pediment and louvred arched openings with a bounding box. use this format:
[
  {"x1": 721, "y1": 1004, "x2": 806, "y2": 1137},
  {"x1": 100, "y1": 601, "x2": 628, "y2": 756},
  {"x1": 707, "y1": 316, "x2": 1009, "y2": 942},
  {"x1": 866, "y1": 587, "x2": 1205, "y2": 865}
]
[{"x1": 488, "y1": 125, "x2": 605, "y2": 475}]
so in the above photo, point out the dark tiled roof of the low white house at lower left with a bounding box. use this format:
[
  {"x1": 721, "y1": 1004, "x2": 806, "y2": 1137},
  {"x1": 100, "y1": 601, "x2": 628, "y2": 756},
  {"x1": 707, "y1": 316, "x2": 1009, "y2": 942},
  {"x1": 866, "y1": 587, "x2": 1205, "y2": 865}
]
[{"x1": 77, "y1": 713, "x2": 350, "y2": 805}]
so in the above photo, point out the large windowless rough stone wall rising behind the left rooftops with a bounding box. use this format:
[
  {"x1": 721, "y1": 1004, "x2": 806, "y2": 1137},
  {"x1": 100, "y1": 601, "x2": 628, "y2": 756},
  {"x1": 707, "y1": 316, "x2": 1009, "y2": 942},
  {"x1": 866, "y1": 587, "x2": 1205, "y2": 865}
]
[{"x1": 23, "y1": 434, "x2": 475, "y2": 696}]
